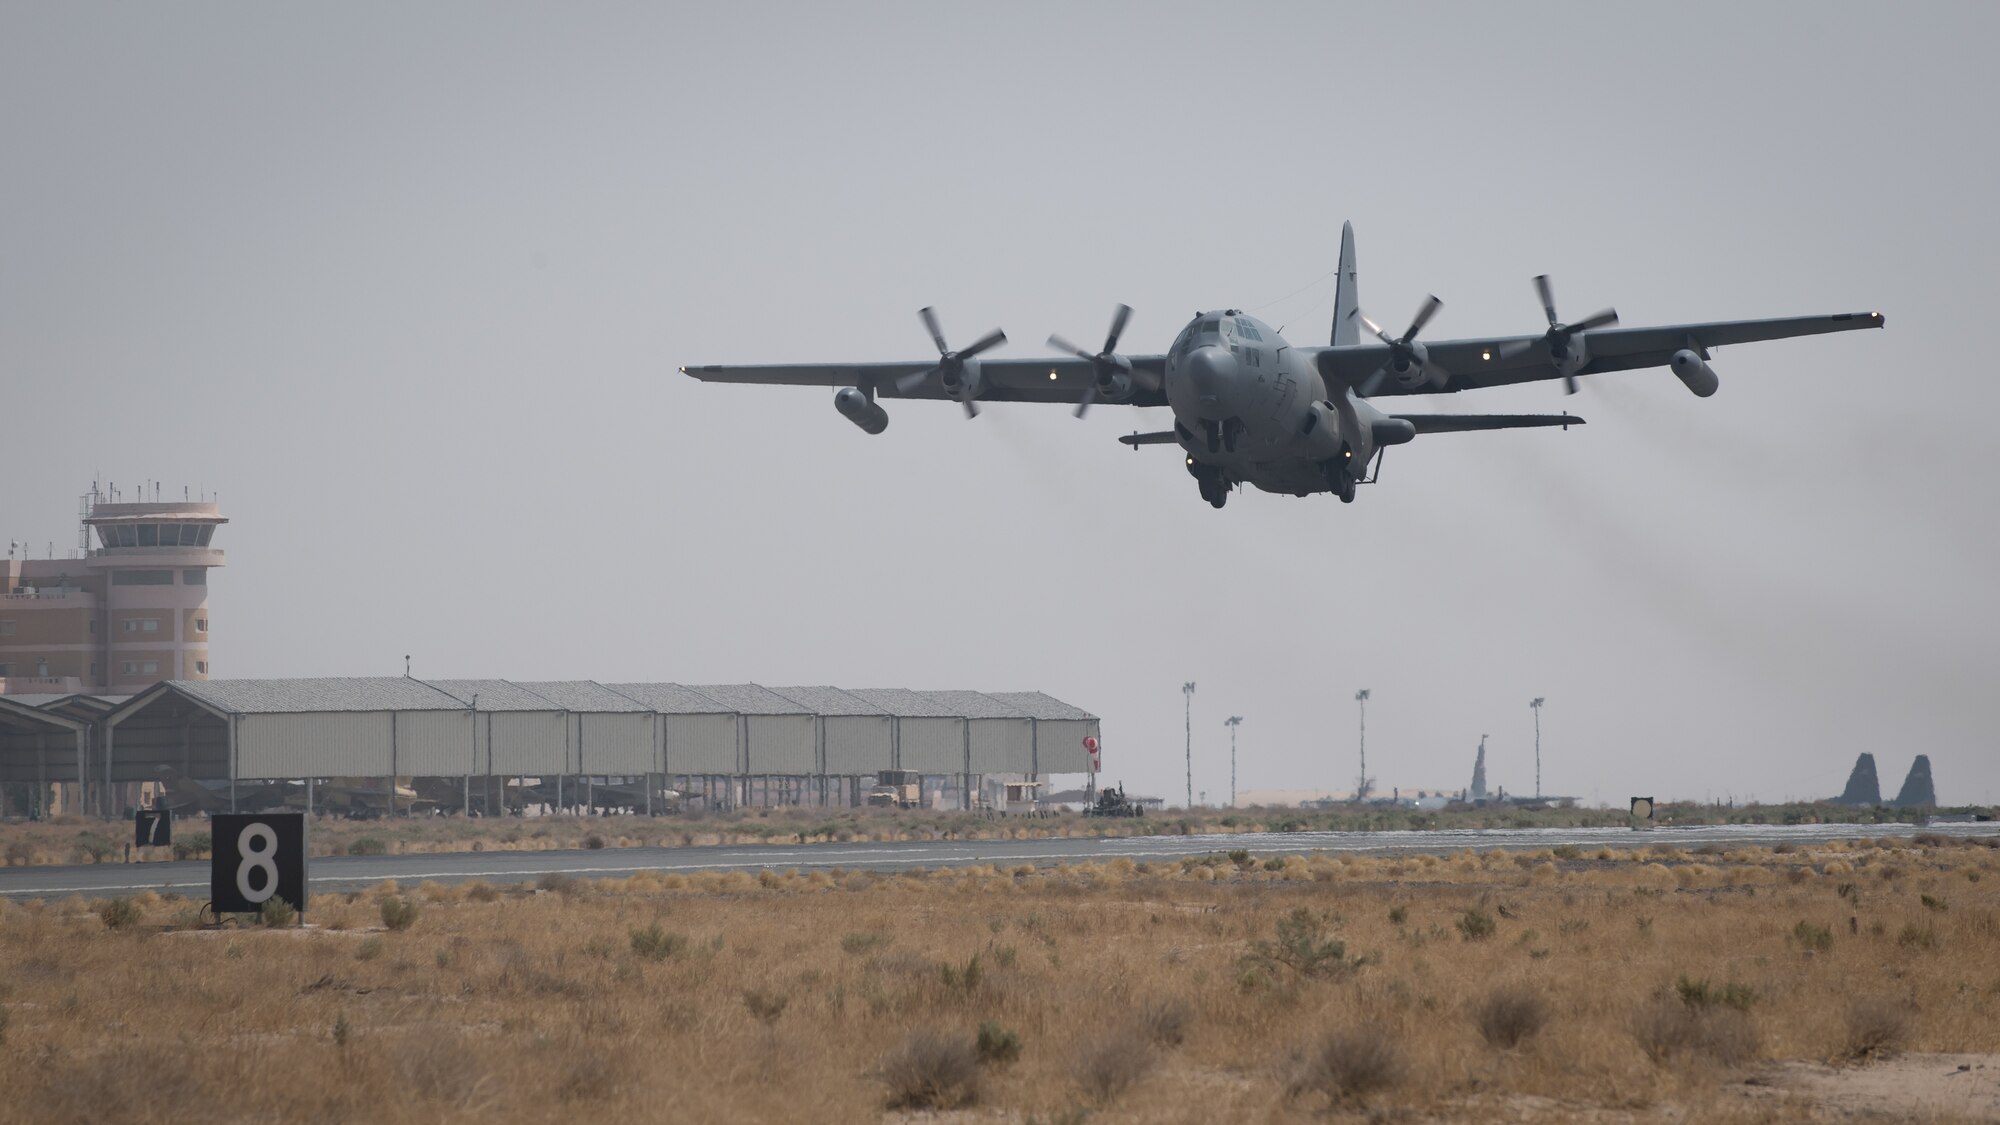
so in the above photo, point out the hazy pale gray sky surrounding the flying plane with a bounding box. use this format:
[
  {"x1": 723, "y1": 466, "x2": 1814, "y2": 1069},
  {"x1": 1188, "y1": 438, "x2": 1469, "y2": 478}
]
[{"x1": 0, "y1": 2, "x2": 2000, "y2": 803}]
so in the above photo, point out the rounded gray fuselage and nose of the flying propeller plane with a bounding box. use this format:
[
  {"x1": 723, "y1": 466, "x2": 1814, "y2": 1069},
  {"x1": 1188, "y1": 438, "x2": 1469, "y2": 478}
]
[{"x1": 1166, "y1": 308, "x2": 1406, "y2": 494}]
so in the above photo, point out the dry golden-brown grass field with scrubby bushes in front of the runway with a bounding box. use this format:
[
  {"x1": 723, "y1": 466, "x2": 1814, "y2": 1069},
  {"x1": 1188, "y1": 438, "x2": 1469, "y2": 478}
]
[{"x1": 0, "y1": 837, "x2": 2000, "y2": 1123}]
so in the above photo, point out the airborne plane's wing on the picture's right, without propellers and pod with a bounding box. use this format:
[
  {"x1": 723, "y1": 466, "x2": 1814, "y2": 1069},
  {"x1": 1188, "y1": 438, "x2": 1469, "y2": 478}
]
[{"x1": 1312, "y1": 312, "x2": 1882, "y2": 398}]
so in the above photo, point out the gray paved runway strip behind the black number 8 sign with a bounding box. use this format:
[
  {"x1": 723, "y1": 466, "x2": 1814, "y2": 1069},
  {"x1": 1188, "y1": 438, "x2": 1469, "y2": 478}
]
[{"x1": 0, "y1": 808, "x2": 2000, "y2": 899}]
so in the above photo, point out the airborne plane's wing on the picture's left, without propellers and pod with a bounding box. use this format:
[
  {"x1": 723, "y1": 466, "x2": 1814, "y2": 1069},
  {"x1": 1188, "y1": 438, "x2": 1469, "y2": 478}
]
[{"x1": 680, "y1": 356, "x2": 1168, "y2": 406}]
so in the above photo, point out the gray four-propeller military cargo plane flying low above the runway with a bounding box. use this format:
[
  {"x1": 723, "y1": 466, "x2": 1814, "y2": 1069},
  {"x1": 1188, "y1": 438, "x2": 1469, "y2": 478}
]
[{"x1": 680, "y1": 224, "x2": 1882, "y2": 508}]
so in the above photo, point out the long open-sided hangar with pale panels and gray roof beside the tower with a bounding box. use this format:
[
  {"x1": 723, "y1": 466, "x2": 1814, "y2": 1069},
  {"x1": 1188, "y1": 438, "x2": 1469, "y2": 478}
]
[{"x1": 23, "y1": 677, "x2": 1098, "y2": 811}]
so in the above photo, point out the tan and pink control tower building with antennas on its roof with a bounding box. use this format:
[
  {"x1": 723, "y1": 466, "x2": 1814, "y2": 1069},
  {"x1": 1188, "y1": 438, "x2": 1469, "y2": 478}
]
[{"x1": 0, "y1": 488, "x2": 228, "y2": 695}]
